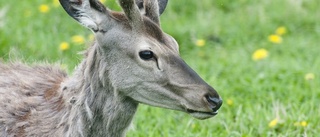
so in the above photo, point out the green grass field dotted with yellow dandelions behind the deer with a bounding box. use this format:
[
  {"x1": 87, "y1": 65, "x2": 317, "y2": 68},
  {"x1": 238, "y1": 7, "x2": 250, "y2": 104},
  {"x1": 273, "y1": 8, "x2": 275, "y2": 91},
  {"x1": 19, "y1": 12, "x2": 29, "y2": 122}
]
[{"x1": 0, "y1": 0, "x2": 320, "y2": 137}]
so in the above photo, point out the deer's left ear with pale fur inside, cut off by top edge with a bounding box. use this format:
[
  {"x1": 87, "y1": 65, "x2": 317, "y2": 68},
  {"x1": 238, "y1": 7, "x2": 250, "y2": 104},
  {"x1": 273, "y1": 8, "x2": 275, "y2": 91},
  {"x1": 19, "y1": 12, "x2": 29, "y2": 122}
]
[{"x1": 59, "y1": 0, "x2": 110, "y2": 32}]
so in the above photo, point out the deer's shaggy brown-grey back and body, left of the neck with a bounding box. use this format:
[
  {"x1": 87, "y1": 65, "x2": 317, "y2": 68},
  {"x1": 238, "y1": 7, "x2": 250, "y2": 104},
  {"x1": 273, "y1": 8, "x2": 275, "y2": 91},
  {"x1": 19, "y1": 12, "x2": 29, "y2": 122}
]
[{"x1": 0, "y1": 64, "x2": 66, "y2": 137}]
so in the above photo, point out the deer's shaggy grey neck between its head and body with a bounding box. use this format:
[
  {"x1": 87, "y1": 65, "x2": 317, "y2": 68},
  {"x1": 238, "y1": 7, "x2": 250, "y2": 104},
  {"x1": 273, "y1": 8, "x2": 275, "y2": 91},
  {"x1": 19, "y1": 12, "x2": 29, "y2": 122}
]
[{"x1": 62, "y1": 44, "x2": 138, "y2": 137}]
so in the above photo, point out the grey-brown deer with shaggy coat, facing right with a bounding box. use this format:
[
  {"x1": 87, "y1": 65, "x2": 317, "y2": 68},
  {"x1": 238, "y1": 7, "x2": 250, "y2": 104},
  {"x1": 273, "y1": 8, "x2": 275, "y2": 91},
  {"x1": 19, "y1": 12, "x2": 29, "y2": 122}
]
[{"x1": 0, "y1": 0, "x2": 222, "y2": 137}]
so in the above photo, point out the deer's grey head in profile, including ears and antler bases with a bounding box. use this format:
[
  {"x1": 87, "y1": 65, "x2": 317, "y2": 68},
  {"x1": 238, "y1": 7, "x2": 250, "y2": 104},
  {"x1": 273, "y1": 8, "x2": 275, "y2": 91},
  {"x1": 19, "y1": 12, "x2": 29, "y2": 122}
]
[{"x1": 60, "y1": 0, "x2": 222, "y2": 119}]
